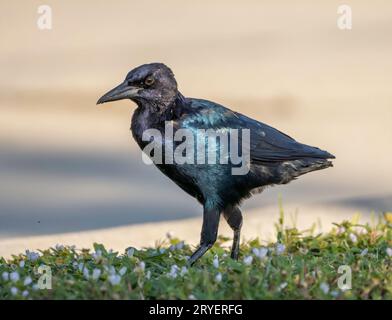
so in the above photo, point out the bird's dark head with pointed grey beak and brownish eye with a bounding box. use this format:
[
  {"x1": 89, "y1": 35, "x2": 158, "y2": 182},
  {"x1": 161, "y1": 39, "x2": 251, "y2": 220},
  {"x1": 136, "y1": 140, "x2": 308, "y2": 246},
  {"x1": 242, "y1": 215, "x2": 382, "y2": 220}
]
[{"x1": 97, "y1": 63, "x2": 177, "y2": 105}]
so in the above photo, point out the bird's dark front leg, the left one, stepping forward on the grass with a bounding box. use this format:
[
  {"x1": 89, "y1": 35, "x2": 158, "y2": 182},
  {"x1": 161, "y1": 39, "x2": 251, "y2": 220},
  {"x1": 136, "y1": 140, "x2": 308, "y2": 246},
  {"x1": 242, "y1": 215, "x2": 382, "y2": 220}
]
[{"x1": 189, "y1": 207, "x2": 220, "y2": 265}]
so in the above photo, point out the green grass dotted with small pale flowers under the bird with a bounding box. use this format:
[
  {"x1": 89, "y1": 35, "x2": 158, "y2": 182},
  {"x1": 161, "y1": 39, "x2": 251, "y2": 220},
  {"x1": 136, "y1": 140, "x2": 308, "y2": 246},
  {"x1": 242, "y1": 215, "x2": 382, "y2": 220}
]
[{"x1": 0, "y1": 214, "x2": 392, "y2": 299}]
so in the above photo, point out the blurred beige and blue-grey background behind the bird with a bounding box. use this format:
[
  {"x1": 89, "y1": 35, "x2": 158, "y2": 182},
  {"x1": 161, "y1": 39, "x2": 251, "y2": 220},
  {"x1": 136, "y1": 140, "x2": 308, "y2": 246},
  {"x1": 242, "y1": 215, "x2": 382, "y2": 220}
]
[{"x1": 0, "y1": 0, "x2": 392, "y2": 240}]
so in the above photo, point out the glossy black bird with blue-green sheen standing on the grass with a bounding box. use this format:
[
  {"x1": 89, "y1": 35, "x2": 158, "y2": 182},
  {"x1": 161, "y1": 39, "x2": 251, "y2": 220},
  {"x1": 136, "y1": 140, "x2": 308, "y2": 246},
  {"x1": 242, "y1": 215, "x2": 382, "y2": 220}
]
[{"x1": 97, "y1": 63, "x2": 335, "y2": 265}]
